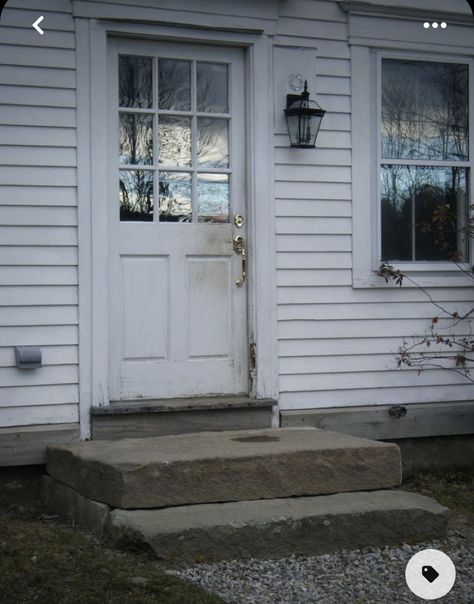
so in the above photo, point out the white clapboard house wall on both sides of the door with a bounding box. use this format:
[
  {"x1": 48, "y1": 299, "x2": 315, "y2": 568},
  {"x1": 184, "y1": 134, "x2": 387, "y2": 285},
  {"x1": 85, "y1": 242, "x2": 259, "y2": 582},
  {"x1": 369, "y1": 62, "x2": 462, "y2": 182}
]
[{"x1": 0, "y1": 0, "x2": 472, "y2": 456}]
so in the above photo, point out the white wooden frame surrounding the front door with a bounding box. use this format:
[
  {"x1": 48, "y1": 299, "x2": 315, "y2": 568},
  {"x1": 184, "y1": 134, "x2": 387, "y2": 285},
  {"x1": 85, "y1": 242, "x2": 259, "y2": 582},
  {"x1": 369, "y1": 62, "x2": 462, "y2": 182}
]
[{"x1": 76, "y1": 18, "x2": 278, "y2": 438}]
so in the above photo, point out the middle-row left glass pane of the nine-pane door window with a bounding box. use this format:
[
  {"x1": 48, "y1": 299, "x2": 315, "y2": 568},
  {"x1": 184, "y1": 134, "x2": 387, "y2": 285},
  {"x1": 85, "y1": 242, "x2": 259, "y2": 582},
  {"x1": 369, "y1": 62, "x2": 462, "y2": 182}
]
[{"x1": 119, "y1": 113, "x2": 153, "y2": 165}]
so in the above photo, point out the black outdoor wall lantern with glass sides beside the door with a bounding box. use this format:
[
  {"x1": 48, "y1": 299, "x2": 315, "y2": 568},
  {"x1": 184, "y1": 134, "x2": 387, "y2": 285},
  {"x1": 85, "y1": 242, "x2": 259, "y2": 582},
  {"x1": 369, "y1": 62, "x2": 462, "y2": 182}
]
[{"x1": 285, "y1": 80, "x2": 326, "y2": 149}]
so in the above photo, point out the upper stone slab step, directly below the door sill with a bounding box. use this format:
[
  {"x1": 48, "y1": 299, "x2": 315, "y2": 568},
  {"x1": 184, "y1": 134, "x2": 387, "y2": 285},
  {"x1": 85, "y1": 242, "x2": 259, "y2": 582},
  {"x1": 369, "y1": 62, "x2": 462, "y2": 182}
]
[{"x1": 46, "y1": 428, "x2": 401, "y2": 509}]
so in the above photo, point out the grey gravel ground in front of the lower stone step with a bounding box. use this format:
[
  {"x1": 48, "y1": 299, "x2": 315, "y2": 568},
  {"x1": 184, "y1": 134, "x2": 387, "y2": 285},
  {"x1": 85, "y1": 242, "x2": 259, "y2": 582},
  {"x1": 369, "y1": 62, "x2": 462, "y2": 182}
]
[{"x1": 170, "y1": 531, "x2": 474, "y2": 604}]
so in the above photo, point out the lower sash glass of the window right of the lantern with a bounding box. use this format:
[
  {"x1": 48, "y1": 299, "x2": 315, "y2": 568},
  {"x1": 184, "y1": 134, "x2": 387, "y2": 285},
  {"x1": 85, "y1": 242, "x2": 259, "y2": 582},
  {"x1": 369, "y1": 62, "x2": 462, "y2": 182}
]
[{"x1": 381, "y1": 165, "x2": 468, "y2": 260}]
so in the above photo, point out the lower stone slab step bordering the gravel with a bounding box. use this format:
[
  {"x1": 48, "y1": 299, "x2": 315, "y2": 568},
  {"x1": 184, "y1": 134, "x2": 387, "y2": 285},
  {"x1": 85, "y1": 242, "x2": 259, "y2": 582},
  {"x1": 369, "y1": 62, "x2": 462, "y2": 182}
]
[{"x1": 42, "y1": 476, "x2": 448, "y2": 565}]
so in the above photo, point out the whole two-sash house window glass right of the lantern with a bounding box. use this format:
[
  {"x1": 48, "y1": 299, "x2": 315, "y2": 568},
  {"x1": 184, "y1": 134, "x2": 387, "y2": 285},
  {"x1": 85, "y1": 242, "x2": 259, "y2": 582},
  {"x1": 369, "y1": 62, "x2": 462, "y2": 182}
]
[{"x1": 380, "y1": 58, "x2": 470, "y2": 261}]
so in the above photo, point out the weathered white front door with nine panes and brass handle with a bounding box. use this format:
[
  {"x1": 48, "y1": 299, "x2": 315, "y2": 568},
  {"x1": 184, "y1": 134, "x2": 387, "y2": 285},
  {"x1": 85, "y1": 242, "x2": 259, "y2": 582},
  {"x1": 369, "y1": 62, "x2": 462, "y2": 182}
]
[{"x1": 108, "y1": 40, "x2": 248, "y2": 400}]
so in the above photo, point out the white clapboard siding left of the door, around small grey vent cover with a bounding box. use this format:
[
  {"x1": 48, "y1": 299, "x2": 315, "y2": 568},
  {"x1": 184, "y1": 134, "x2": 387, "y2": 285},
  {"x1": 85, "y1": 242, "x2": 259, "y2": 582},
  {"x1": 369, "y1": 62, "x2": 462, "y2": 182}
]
[{"x1": 0, "y1": 0, "x2": 79, "y2": 426}]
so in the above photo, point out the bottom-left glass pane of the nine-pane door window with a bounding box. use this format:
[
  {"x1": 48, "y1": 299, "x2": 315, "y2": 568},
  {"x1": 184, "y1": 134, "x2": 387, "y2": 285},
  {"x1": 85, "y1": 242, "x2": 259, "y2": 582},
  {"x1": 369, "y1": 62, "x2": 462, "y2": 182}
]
[{"x1": 120, "y1": 170, "x2": 153, "y2": 222}]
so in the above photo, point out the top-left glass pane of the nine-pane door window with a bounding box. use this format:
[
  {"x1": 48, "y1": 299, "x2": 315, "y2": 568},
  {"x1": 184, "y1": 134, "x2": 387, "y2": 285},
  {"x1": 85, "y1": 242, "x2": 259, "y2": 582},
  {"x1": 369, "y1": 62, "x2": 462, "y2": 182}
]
[{"x1": 119, "y1": 56, "x2": 153, "y2": 109}]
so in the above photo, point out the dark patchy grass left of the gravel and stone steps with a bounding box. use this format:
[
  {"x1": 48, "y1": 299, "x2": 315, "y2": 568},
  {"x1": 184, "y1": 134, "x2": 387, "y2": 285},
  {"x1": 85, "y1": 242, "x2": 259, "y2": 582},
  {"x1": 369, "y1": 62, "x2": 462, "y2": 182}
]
[{"x1": 0, "y1": 477, "x2": 222, "y2": 604}]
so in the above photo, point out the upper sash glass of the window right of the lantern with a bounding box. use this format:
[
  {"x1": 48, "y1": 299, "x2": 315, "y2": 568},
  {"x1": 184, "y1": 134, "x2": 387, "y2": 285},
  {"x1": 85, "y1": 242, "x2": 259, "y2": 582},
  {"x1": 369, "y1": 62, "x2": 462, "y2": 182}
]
[{"x1": 382, "y1": 59, "x2": 469, "y2": 161}]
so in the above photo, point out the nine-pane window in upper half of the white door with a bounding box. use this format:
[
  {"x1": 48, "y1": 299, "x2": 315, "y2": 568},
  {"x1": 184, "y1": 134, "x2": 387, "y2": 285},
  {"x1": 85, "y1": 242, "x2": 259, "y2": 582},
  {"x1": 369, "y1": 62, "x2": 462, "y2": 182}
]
[{"x1": 119, "y1": 55, "x2": 231, "y2": 223}]
